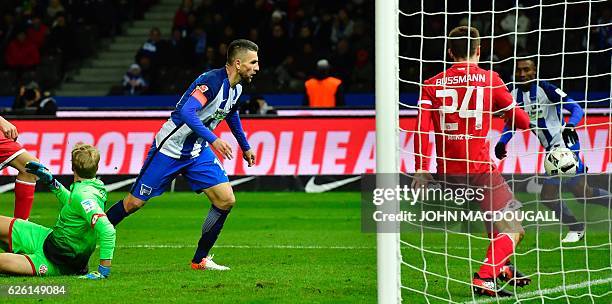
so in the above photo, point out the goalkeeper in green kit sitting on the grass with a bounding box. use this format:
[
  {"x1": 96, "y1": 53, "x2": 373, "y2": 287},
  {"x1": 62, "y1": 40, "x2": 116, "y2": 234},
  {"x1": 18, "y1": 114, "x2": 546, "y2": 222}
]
[{"x1": 0, "y1": 144, "x2": 115, "y2": 279}]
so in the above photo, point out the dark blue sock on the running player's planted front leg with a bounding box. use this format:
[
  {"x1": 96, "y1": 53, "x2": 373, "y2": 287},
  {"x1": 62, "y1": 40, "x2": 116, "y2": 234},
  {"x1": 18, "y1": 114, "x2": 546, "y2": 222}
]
[{"x1": 191, "y1": 205, "x2": 231, "y2": 263}]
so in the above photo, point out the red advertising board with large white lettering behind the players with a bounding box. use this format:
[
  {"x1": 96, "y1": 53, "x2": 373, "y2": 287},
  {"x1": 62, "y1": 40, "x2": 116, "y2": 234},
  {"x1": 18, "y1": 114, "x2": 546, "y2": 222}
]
[{"x1": 2, "y1": 115, "x2": 612, "y2": 175}]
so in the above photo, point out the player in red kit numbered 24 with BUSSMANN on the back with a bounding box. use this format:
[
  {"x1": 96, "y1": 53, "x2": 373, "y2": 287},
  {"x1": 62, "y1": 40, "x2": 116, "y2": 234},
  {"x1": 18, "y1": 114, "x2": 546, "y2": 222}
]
[{"x1": 413, "y1": 26, "x2": 530, "y2": 296}]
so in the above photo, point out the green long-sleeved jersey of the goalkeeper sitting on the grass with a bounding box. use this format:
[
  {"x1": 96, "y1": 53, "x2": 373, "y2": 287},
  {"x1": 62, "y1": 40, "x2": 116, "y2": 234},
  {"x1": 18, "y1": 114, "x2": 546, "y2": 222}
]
[{"x1": 44, "y1": 179, "x2": 115, "y2": 272}]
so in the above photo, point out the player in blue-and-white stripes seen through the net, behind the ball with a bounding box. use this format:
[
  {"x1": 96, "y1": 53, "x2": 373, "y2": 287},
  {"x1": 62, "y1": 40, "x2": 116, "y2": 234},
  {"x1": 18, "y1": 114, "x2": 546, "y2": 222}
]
[{"x1": 495, "y1": 58, "x2": 610, "y2": 243}]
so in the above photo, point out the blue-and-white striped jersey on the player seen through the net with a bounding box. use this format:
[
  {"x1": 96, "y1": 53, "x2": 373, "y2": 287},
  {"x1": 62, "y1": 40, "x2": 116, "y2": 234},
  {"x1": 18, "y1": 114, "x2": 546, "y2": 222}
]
[{"x1": 512, "y1": 81, "x2": 583, "y2": 150}]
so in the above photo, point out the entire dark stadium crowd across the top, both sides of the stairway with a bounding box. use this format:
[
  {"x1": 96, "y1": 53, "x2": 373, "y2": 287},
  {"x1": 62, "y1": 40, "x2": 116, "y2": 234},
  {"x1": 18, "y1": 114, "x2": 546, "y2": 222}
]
[{"x1": 0, "y1": 0, "x2": 612, "y2": 100}]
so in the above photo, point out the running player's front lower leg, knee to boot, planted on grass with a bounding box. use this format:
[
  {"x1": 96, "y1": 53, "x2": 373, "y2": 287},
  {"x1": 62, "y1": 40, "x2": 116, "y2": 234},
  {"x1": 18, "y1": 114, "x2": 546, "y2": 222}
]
[{"x1": 191, "y1": 183, "x2": 236, "y2": 270}]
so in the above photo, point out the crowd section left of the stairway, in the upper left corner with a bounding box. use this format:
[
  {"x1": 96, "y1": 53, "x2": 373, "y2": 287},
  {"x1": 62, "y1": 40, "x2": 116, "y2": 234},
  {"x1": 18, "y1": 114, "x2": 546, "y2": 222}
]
[{"x1": 0, "y1": 0, "x2": 156, "y2": 95}]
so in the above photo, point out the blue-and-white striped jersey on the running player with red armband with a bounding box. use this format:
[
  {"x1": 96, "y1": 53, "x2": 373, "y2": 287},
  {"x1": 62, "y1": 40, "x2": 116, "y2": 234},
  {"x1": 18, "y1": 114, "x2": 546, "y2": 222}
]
[{"x1": 155, "y1": 68, "x2": 242, "y2": 159}]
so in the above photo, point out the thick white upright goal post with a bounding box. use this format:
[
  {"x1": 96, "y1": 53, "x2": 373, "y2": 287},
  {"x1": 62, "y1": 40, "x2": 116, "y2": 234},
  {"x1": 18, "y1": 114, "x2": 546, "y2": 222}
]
[{"x1": 374, "y1": 0, "x2": 401, "y2": 303}]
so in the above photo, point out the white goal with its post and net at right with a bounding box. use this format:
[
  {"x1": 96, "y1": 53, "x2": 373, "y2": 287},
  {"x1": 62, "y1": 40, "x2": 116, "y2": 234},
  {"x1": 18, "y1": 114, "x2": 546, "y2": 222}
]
[{"x1": 376, "y1": 0, "x2": 612, "y2": 303}]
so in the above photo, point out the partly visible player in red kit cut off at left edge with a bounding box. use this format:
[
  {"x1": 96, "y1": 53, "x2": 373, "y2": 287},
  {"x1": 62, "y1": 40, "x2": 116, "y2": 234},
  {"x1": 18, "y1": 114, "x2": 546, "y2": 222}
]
[{"x1": 0, "y1": 116, "x2": 38, "y2": 220}]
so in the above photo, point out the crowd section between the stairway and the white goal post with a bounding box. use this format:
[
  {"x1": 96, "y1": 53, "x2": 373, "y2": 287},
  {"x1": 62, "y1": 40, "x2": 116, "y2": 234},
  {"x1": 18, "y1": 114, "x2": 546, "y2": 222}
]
[{"x1": 125, "y1": 0, "x2": 374, "y2": 93}]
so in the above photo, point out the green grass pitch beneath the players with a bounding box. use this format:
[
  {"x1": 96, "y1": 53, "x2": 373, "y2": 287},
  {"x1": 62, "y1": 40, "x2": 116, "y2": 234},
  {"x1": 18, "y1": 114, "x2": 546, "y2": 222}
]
[{"x1": 0, "y1": 192, "x2": 612, "y2": 304}]
